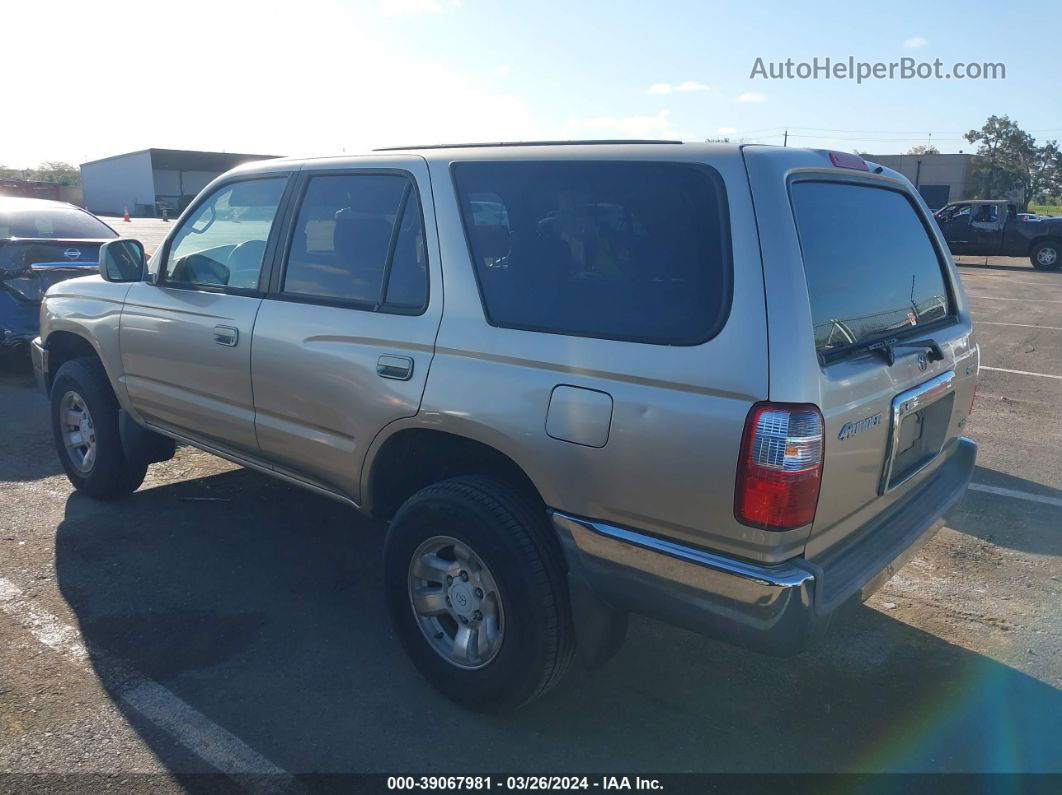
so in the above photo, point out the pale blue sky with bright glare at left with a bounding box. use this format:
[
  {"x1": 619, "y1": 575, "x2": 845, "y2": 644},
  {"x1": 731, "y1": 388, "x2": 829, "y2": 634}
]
[{"x1": 0, "y1": 0, "x2": 1062, "y2": 168}]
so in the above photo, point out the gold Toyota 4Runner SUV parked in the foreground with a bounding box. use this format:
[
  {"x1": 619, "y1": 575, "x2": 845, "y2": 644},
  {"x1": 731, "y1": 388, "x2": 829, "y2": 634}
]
[{"x1": 34, "y1": 142, "x2": 978, "y2": 710}]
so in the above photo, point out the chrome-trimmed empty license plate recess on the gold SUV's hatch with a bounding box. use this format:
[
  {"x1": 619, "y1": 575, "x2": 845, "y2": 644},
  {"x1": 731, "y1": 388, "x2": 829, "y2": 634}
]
[{"x1": 880, "y1": 373, "x2": 955, "y2": 494}]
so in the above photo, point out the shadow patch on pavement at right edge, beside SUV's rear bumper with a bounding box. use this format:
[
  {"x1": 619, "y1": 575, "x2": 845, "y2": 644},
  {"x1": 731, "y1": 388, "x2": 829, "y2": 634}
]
[{"x1": 947, "y1": 467, "x2": 1062, "y2": 557}]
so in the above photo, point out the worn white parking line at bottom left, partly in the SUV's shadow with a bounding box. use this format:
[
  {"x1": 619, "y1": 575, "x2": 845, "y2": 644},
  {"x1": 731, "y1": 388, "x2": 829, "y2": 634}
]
[{"x1": 0, "y1": 577, "x2": 302, "y2": 792}]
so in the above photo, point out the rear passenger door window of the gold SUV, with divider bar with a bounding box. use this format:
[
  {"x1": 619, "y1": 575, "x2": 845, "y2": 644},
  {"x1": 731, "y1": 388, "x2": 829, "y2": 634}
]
[{"x1": 282, "y1": 174, "x2": 428, "y2": 310}]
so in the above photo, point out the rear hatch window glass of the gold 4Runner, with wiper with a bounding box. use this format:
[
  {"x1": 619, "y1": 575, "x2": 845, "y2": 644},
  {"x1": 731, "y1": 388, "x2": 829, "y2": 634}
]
[{"x1": 792, "y1": 182, "x2": 952, "y2": 353}]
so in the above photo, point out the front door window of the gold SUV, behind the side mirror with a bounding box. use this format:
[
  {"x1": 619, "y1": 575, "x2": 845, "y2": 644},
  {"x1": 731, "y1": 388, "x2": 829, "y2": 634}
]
[{"x1": 162, "y1": 177, "x2": 288, "y2": 290}]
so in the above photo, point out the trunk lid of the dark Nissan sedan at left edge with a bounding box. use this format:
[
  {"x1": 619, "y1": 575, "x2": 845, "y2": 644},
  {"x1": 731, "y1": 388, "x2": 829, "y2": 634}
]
[{"x1": 0, "y1": 238, "x2": 106, "y2": 301}]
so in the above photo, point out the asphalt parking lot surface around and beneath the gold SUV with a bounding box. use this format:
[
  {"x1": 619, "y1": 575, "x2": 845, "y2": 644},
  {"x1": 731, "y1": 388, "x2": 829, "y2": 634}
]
[{"x1": 0, "y1": 254, "x2": 1062, "y2": 776}]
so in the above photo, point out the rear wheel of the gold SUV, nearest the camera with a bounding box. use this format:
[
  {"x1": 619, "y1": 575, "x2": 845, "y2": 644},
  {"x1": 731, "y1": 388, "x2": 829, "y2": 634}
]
[{"x1": 383, "y1": 477, "x2": 575, "y2": 712}]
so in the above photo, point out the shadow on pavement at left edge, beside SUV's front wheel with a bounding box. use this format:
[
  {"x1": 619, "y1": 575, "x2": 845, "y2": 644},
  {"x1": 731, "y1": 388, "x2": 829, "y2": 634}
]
[{"x1": 0, "y1": 351, "x2": 63, "y2": 481}]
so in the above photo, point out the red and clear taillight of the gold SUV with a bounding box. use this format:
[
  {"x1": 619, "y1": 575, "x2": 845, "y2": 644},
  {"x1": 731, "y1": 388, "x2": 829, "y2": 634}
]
[{"x1": 734, "y1": 403, "x2": 823, "y2": 530}]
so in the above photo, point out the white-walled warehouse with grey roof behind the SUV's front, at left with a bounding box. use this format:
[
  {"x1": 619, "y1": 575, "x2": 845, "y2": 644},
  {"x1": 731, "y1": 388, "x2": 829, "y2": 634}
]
[{"x1": 81, "y1": 149, "x2": 276, "y2": 218}]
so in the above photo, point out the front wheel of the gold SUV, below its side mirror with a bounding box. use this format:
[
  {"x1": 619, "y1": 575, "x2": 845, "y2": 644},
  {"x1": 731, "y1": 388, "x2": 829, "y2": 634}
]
[{"x1": 51, "y1": 358, "x2": 148, "y2": 500}]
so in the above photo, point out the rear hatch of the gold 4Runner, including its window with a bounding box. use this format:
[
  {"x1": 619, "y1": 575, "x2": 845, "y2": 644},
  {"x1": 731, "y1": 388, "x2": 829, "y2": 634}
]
[{"x1": 746, "y1": 148, "x2": 977, "y2": 559}]
